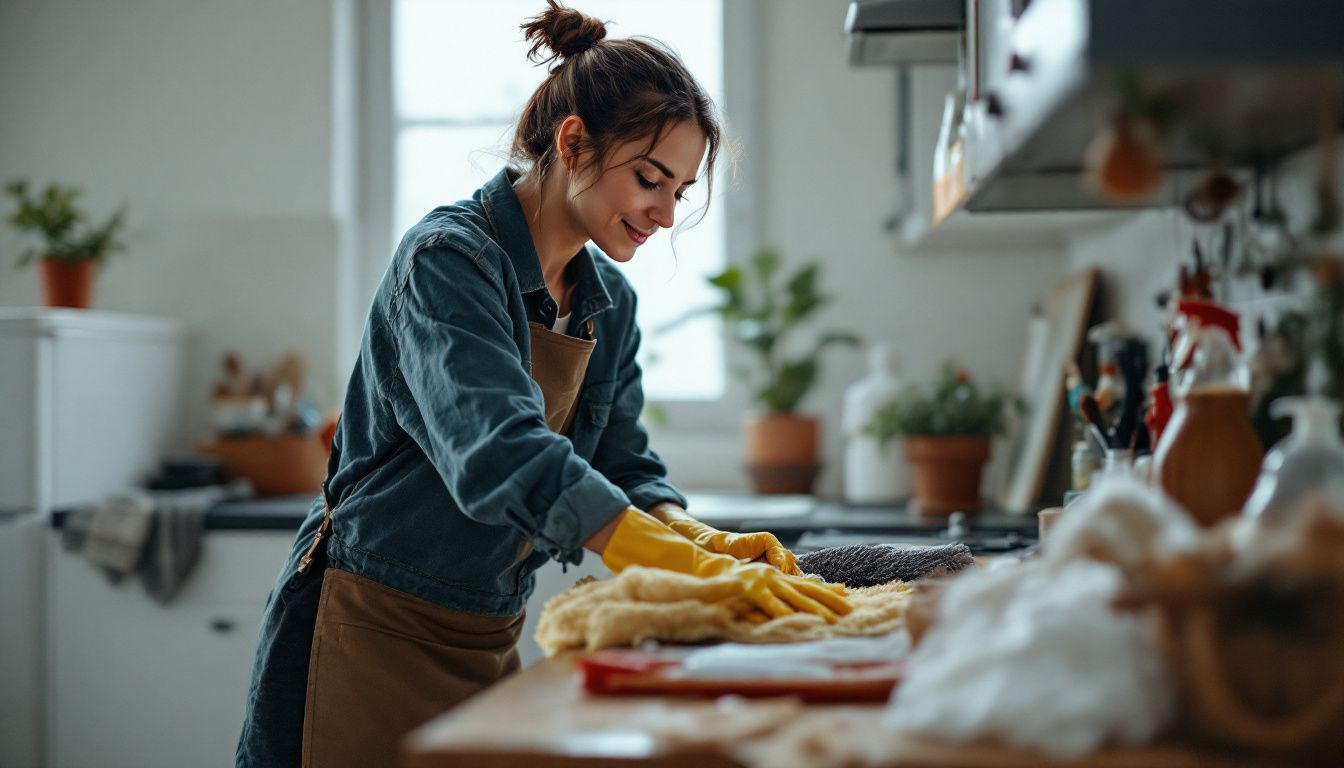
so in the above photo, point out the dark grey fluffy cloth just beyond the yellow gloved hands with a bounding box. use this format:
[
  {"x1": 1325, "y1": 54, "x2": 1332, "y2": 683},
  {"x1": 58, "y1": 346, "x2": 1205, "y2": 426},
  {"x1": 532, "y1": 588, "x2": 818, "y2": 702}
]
[{"x1": 798, "y1": 542, "x2": 974, "y2": 588}]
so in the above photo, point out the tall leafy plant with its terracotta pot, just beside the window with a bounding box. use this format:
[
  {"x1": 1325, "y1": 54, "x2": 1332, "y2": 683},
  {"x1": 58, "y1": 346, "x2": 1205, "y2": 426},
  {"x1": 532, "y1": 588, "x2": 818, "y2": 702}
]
[{"x1": 672, "y1": 249, "x2": 859, "y2": 494}]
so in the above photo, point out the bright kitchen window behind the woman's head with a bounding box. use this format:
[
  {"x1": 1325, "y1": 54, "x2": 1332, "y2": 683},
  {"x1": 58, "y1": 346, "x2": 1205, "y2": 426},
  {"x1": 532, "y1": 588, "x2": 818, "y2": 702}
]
[{"x1": 391, "y1": 0, "x2": 727, "y2": 401}]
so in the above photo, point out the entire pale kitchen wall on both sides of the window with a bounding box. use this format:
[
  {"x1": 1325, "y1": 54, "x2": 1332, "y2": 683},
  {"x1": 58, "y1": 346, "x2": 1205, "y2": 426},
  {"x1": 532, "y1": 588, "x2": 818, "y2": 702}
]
[{"x1": 0, "y1": 0, "x2": 1063, "y2": 495}]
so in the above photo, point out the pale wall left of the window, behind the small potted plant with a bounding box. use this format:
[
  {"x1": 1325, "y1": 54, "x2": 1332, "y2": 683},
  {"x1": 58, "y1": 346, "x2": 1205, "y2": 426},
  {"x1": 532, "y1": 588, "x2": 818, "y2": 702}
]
[{"x1": 0, "y1": 0, "x2": 344, "y2": 441}]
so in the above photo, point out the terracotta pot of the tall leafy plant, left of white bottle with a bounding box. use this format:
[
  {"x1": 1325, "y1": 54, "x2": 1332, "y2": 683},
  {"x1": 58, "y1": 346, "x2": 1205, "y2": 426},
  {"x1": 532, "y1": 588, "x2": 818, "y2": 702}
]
[{"x1": 743, "y1": 413, "x2": 821, "y2": 494}]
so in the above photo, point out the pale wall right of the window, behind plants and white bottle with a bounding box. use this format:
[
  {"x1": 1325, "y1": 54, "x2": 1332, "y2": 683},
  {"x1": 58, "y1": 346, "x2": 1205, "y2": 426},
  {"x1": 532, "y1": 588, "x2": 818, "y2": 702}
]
[{"x1": 655, "y1": 0, "x2": 1063, "y2": 496}]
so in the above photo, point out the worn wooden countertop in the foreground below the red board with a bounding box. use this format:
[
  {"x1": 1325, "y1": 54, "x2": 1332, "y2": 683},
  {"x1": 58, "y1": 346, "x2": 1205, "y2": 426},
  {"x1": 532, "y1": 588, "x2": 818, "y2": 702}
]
[{"x1": 403, "y1": 654, "x2": 1253, "y2": 768}]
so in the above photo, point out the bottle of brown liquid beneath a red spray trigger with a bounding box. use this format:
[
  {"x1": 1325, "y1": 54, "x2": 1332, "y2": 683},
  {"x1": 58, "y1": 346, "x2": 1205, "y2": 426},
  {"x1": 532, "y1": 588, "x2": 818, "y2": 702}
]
[{"x1": 1153, "y1": 324, "x2": 1263, "y2": 526}]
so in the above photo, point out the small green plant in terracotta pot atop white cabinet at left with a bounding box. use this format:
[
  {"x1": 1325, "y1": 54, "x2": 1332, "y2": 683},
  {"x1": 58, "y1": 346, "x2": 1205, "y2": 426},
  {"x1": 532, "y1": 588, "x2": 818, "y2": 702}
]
[{"x1": 5, "y1": 180, "x2": 125, "y2": 309}]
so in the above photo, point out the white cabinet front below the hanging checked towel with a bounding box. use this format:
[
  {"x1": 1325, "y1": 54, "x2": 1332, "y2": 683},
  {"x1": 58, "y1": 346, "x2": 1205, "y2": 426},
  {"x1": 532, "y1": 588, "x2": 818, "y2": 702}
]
[{"x1": 50, "y1": 531, "x2": 293, "y2": 768}]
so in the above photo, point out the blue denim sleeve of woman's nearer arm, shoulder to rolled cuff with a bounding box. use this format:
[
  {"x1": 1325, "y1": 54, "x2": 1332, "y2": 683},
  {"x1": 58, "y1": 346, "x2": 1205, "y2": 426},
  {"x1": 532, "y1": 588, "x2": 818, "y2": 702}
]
[{"x1": 392, "y1": 245, "x2": 630, "y2": 562}]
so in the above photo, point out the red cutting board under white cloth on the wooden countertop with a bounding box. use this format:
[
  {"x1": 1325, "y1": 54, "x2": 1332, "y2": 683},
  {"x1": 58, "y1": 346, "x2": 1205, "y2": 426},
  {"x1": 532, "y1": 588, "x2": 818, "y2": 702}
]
[{"x1": 578, "y1": 648, "x2": 905, "y2": 702}]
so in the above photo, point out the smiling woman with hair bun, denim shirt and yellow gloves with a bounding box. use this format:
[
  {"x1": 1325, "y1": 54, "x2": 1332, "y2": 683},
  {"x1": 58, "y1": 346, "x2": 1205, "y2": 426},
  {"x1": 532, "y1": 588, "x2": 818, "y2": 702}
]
[{"x1": 238, "y1": 0, "x2": 848, "y2": 767}]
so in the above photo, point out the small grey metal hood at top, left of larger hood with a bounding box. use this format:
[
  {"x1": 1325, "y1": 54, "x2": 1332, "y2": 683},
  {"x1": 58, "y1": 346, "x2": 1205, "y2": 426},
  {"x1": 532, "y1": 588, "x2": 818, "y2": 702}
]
[{"x1": 844, "y1": 0, "x2": 966, "y2": 65}]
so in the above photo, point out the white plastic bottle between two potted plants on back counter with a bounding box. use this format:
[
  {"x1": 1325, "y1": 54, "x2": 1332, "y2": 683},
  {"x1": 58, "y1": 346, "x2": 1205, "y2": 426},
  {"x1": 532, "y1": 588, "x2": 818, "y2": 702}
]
[{"x1": 840, "y1": 344, "x2": 910, "y2": 504}]
